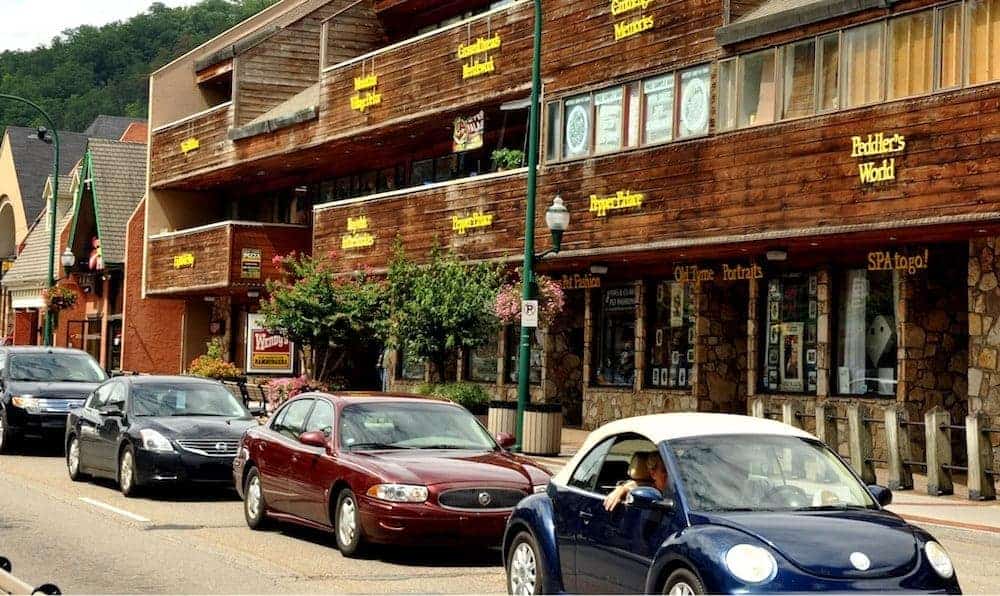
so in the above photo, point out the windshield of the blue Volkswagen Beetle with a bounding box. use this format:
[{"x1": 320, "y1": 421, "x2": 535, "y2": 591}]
[{"x1": 668, "y1": 435, "x2": 875, "y2": 511}]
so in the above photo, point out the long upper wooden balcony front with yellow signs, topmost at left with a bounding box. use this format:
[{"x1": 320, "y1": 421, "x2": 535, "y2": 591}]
[{"x1": 150, "y1": 2, "x2": 533, "y2": 190}]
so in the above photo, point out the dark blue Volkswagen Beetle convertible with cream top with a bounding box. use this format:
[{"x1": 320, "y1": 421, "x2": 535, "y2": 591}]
[{"x1": 503, "y1": 414, "x2": 961, "y2": 595}]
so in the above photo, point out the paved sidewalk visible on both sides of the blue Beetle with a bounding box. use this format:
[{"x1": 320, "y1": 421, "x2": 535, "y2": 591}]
[{"x1": 531, "y1": 428, "x2": 1000, "y2": 535}]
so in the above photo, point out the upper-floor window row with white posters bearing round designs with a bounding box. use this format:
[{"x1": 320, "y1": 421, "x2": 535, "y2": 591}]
[{"x1": 545, "y1": 65, "x2": 710, "y2": 161}]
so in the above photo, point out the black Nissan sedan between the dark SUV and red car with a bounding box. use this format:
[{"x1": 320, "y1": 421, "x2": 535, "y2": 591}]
[{"x1": 66, "y1": 376, "x2": 258, "y2": 497}]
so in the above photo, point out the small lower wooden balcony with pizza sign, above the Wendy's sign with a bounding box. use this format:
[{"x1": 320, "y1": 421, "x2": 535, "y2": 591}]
[{"x1": 146, "y1": 221, "x2": 309, "y2": 296}]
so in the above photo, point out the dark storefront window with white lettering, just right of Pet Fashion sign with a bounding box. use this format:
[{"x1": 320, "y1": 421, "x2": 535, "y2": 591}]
[{"x1": 594, "y1": 285, "x2": 636, "y2": 387}]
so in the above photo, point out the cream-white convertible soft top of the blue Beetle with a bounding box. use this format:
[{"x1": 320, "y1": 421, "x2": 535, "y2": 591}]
[{"x1": 552, "y1": 412, "x2": 816, "y2": 485}]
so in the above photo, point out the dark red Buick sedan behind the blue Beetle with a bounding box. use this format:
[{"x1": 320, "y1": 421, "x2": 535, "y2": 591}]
[{"x1": 233, "y1": 393, "x2": 549, "y2": 556}]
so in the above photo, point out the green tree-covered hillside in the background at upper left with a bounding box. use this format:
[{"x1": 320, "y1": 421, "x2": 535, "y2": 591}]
[{"x1": 0, "y1": 0, "x2": 277, "y2": 131}]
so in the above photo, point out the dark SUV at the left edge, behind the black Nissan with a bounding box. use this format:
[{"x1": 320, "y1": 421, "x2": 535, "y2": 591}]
[{"x1": 0, "y1": 347, "x2": 107, "y2": 453}]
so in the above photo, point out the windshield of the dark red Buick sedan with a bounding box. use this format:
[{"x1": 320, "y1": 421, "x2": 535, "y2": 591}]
[{"x1": 340, "y1": 402, "x2": 497, "y2": 451}]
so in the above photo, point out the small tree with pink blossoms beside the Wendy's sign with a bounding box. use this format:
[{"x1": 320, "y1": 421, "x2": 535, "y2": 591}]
[{"x1": 260, "y1": 253, "x2": 385, "y2": 381}]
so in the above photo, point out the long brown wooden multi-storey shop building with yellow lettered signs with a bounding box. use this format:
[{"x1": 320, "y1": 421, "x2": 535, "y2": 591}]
[{"x1": 145, "y1": 0, "x2": 1000, "y2": 458}]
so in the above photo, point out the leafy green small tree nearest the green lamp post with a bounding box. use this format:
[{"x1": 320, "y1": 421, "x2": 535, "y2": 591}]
[{"x1": 382, "y1": 244, "x2": 502, "y2": 380}]
